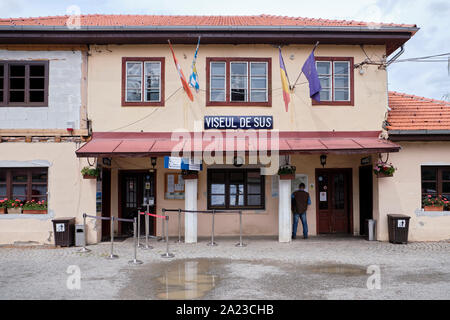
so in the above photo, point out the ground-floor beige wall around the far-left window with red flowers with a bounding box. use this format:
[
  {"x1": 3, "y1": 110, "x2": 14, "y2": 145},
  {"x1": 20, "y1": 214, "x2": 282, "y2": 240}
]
[{"x1": 0, "y1": 143, "x2": 100, "y2": 244}]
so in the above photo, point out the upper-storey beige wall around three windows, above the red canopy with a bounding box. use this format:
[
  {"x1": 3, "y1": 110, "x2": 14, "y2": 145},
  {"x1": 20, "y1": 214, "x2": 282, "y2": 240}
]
[{"x1": 88, "y1": 45, "x2": 387, "y2": 132}]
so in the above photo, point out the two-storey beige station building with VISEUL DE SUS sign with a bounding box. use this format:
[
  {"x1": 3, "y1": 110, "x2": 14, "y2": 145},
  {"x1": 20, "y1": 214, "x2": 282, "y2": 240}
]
[{"x1": 0, "y1": 15, "x2": 450, "y2": 243}]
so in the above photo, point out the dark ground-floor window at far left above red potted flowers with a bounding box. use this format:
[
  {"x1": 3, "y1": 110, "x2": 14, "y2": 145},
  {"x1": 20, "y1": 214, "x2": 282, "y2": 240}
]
[{"x1": 0, "y1": 168, "x2": 48, "y2": 201}]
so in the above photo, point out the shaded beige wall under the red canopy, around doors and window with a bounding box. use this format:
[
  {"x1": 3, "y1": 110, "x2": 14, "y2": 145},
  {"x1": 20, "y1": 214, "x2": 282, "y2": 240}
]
[{"x1": 106, "y1": 155, "x2": 376, "y2": 236}]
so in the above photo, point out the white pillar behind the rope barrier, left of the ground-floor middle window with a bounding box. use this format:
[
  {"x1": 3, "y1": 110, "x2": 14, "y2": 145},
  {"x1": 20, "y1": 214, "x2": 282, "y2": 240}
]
[{"x1": 184, "y1": 179, "x2": 198, "y2": 243}]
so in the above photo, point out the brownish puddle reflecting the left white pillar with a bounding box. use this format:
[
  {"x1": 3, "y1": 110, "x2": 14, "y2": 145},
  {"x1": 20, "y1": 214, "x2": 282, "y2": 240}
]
[{"x1": 156, "y1": 260, "x2": 218, "y2": 300}]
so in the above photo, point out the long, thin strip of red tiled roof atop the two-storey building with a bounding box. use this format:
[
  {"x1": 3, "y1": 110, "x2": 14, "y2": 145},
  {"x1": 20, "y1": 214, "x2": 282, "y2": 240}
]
[{"x1": 0, "y1": 14, "x2": 416, "y2": 27}]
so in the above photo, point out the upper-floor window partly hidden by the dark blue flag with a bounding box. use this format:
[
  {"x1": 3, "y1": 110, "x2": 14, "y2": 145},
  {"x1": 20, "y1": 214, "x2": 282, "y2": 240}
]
[{"x1": 313, "y1": 57, "x2": 354, "y2": 105}]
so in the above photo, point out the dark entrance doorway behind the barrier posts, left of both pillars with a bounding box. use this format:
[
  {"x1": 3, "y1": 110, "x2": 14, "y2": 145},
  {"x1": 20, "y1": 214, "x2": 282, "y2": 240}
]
[{"x1": 119, "y1": 170, "x2": 156, "y2": 236}]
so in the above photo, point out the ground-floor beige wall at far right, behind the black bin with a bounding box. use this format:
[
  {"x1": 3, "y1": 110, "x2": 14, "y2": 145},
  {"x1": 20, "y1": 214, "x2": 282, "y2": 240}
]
[{"x1": 376, "y1": 142, "x2": 450, "y2": 241}]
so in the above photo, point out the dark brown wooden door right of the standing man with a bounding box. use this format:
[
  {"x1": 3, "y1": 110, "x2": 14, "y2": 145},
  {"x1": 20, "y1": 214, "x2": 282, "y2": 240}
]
[{"x1": 316, "y1": 169, "x2": 353, "y2": 234}]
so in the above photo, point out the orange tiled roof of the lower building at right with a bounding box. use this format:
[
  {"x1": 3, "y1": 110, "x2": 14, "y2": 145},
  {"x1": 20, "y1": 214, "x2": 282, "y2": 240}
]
[{"x1": 387, "y1": 91, "x2": 450, "y2": 130}]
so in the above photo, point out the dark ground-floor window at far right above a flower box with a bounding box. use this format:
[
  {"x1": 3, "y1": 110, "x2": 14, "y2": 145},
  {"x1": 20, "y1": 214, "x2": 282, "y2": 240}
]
[{"x1": 421, "y1": 166, "x2": 450, "y2": 210}]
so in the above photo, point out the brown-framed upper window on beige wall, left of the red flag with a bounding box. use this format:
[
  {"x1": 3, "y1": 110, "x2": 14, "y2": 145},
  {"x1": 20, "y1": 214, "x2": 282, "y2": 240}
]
[{"x1": 122, "y1": 58, "x2": 165, "y2": 106}]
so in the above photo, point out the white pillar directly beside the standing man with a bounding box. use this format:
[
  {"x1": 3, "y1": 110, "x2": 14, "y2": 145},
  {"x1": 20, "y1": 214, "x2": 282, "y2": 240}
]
[{"x1": 278, "y1": 179, "x2": 292, "y2": 242}]
